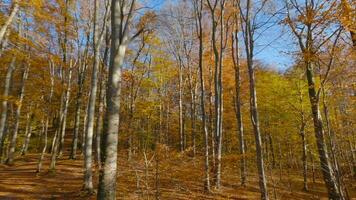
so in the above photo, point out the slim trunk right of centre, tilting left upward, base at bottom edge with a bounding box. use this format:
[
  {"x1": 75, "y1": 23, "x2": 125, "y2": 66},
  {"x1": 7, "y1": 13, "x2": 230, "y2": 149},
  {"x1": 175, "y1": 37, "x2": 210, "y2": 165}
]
[{"x1": 238, "y1": 0, "x2": 269, "y2": 197}]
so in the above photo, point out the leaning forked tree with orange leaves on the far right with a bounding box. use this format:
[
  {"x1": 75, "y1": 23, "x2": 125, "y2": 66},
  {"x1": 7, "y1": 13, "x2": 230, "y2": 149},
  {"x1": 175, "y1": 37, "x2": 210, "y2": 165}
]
[{"x1": 286, "y1": 0, "x2": 345, "y2": 199}]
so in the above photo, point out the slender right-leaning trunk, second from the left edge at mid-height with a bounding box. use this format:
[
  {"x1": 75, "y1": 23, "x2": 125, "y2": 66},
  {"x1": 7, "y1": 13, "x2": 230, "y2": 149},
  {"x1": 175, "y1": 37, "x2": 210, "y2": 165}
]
[{"x1": 6, "y1": 65, "x2": 30, "y2": 165}]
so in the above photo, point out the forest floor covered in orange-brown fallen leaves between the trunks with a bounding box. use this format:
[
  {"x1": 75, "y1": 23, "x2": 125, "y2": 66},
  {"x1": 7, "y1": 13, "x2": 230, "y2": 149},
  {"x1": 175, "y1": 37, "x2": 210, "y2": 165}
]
[{"x1": 0, "y1": 133, "x2": 356, "y2": 200}]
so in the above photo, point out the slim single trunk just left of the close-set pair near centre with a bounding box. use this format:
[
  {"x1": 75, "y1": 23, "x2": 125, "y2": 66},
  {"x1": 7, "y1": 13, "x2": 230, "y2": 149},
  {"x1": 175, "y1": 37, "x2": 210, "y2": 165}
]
[{"x1": 193, "y1": 0, "x2": 210, "y2": 192}]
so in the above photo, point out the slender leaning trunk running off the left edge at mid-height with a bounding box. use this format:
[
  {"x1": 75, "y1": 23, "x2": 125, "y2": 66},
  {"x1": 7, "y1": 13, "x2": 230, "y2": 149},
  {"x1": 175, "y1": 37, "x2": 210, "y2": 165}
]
[{"x1": 0, "y1": 57, "x2": 16, "y2": 149}]
